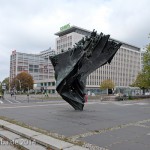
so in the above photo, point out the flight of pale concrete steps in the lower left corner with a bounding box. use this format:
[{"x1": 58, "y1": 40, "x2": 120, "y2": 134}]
[{"x1": 0, "y1": 120, "x2": 86, "y2": 150}]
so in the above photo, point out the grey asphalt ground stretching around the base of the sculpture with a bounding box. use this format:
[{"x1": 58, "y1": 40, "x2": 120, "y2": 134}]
[{"x1": 0, "y1": 96, "x2": 150, "y2": 150}]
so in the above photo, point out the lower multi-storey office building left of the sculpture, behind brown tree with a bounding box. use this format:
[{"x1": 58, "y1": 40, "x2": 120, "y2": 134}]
[{"x1": 10, "y1": 49, "x2": 55, "y2": 93}]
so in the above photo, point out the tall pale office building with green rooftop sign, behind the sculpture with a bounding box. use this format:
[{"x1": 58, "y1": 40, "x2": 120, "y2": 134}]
[{"x1": 55, "y1": 26, "x2": 141, "y2": 91}]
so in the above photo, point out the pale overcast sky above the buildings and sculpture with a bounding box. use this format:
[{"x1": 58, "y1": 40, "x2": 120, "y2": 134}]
[{"x1": 0, "y1": 0, "x2": 150, "y2": 81}]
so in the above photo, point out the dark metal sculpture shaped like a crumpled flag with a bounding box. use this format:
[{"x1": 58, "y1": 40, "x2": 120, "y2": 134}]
[{"x1": 50, "y1": 31, "x2": 122, "y2": 110}]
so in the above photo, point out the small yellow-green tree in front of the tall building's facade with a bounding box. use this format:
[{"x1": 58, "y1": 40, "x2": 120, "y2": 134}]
[{"x1": 100, "y1": 79, "x2": 115, "y2": 94}]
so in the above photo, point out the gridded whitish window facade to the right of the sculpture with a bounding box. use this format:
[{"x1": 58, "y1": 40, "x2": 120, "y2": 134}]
[{"x1": 87, "y1": 46, "x2": 140, "y2": 87}]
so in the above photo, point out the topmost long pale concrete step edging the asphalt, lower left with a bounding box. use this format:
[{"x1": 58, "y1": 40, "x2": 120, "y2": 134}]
[{"x1": 0, "y1": 119, "x2": 88, "y2": 150}]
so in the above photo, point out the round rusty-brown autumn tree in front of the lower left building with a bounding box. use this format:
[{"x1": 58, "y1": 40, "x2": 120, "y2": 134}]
[{"x1": 11, "y1": 72, "x2": 34, "y2": 92}]
